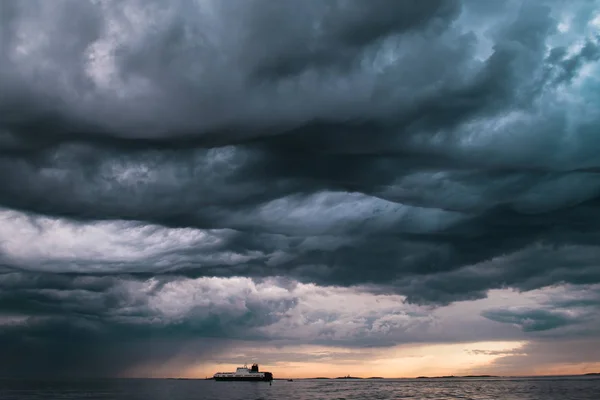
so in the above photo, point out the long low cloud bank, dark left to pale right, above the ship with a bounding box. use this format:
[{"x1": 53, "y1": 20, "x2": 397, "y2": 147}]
[{"x1": 0, "y1": 272, "x2": 523, "y2": 377}]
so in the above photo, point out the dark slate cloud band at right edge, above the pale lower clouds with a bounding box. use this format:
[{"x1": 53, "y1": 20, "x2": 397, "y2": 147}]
[{"x1": 399, "y1": 242, "x2": 600, "y2": 304}]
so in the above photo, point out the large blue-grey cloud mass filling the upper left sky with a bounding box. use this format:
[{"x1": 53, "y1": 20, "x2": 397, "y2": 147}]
[{"x1": 3, "y1": 0, "x2": 460, "y2": 146}]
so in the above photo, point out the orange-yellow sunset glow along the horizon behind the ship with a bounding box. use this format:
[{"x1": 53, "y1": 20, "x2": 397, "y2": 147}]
[{"x1": 127, "y1": 342, "x2": 533, "y2": 378}]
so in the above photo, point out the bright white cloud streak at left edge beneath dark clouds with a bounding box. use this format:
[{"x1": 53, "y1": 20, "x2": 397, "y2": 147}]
[{"x1": 0, "y1": 209, "x2": 252, "y2": 272}]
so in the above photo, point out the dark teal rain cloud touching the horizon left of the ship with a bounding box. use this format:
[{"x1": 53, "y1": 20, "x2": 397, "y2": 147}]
[{"x1": 0, "y1": 316, "x2": 229, "y2": 379}]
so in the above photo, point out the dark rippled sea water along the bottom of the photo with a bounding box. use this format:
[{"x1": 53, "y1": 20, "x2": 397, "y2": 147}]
[{"x1": 0, "y1": 377, "x2": 600, "y2": 400}]
